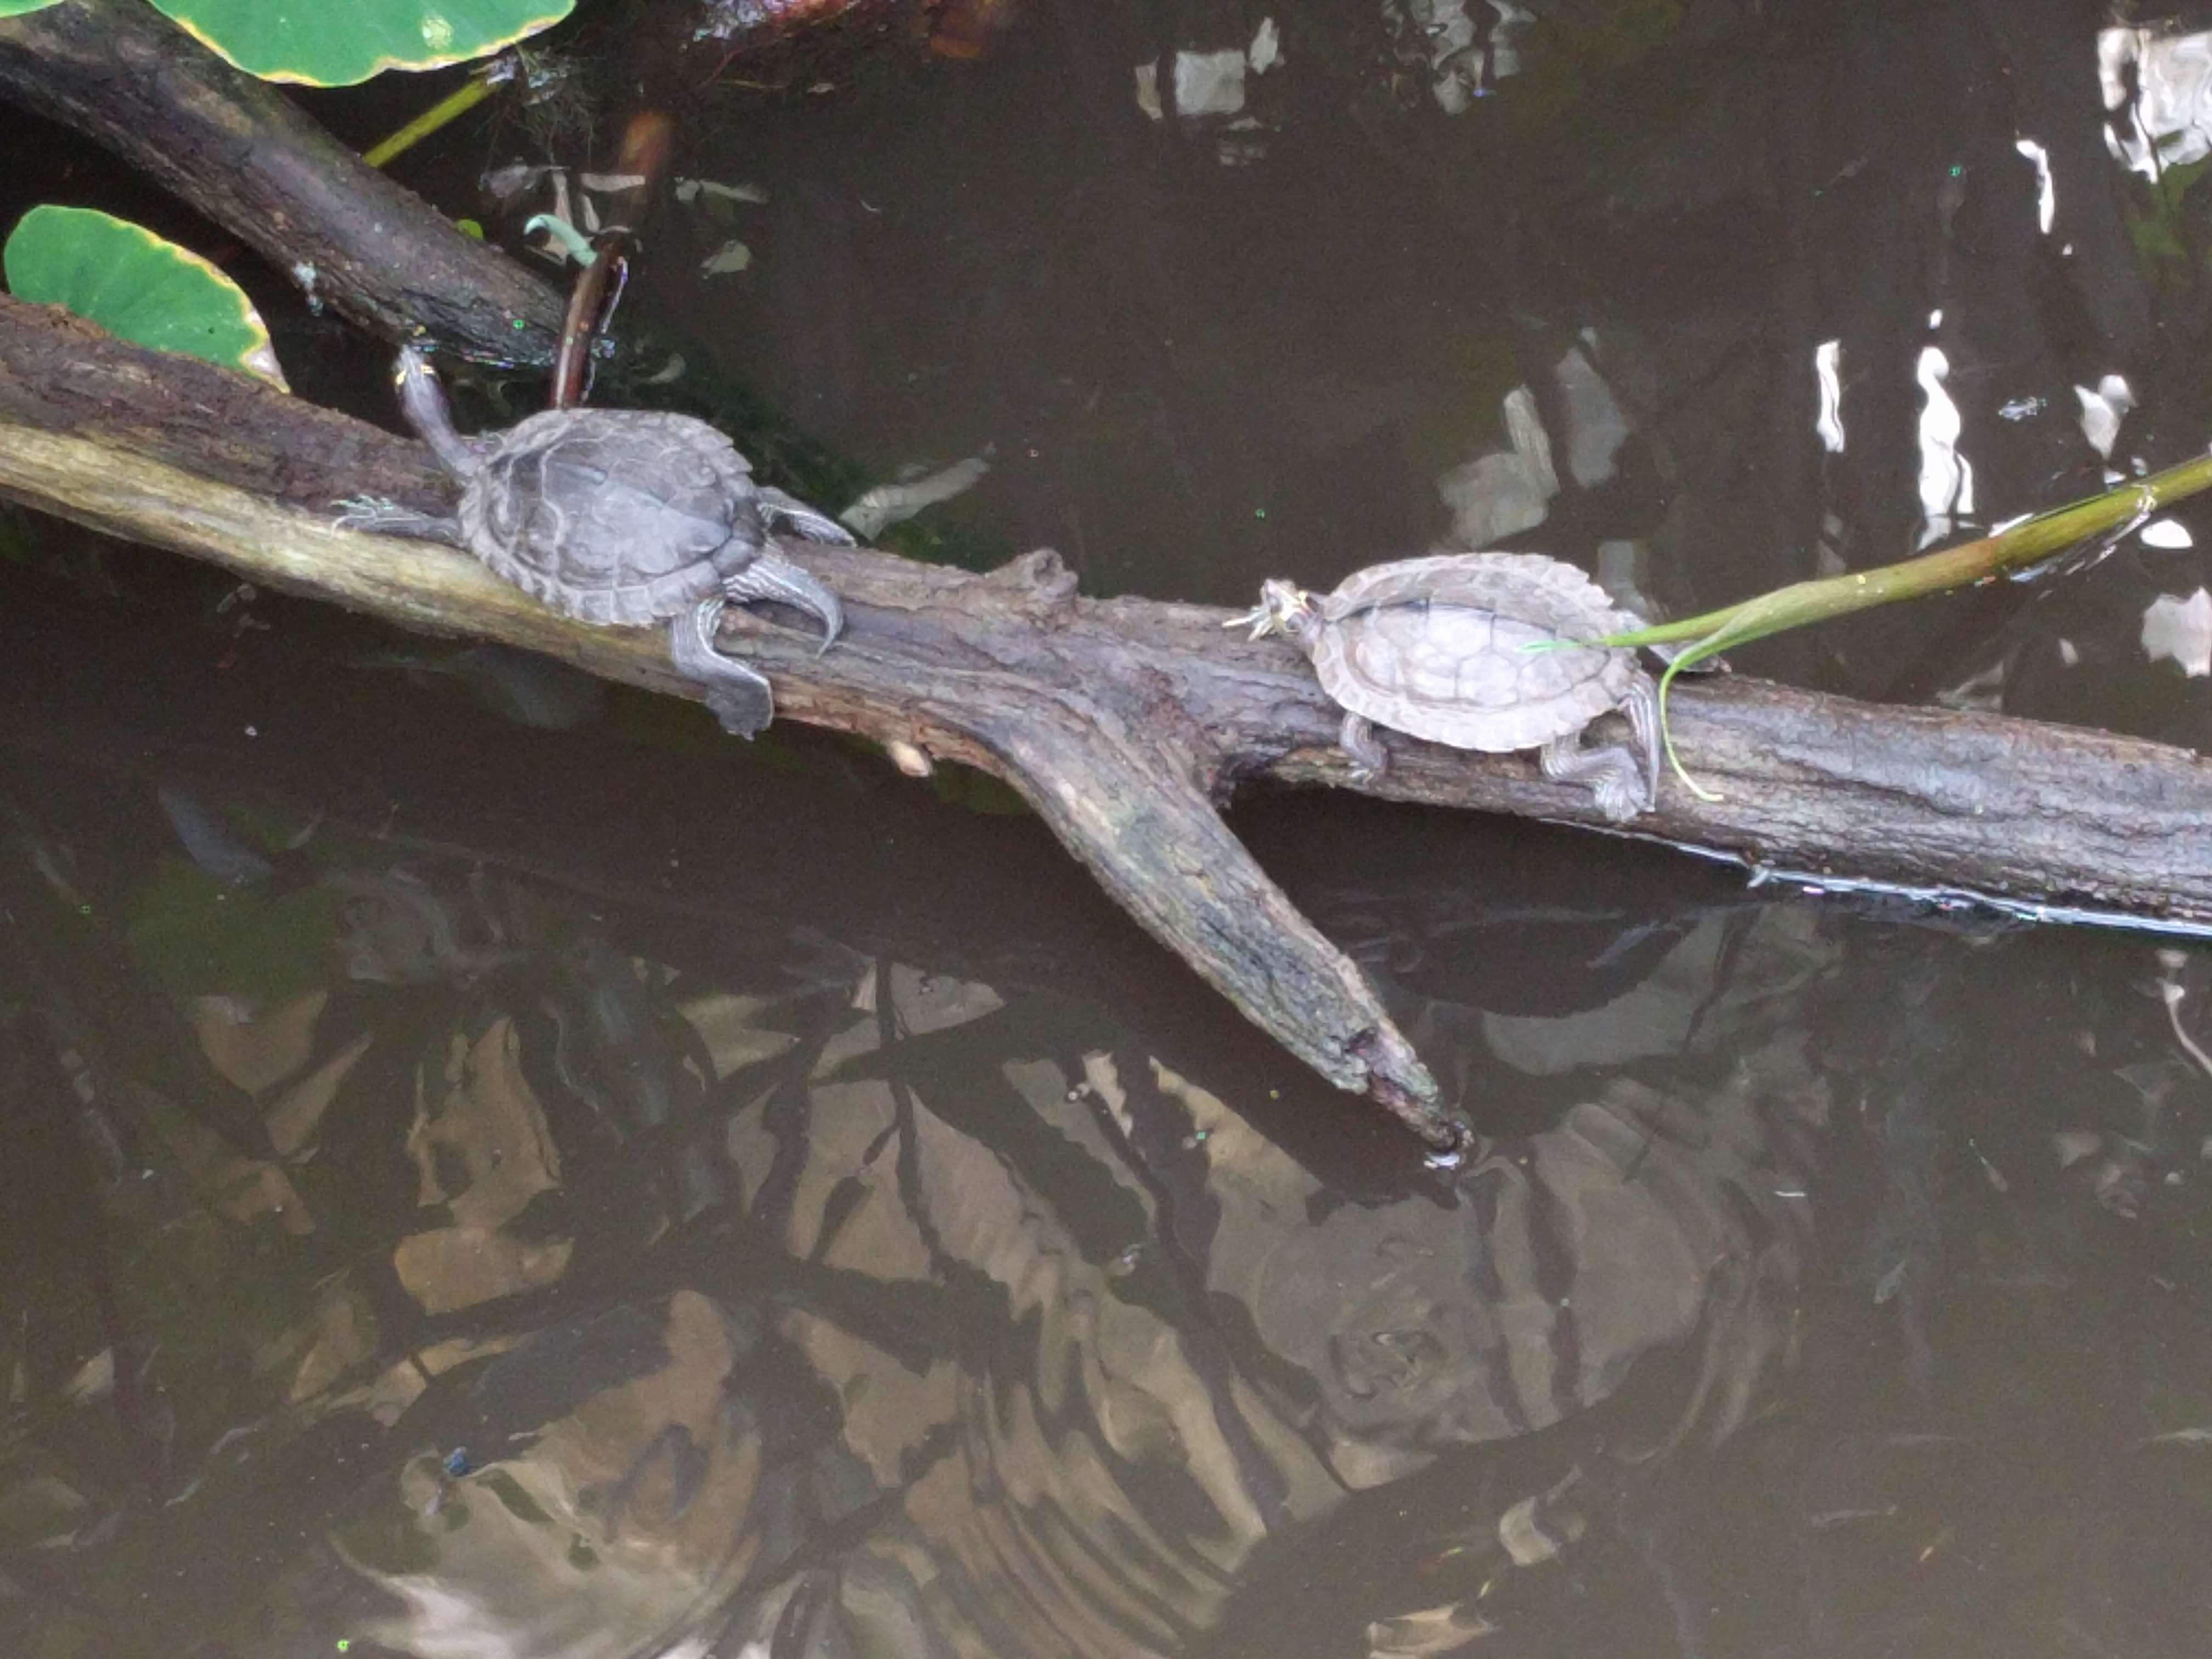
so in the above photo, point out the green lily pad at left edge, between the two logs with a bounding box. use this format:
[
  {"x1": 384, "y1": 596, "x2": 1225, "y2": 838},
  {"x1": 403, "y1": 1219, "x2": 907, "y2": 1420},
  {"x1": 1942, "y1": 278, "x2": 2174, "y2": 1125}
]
[{"x1": 0, "y1": 206, "x2": 290, "y2": 392}]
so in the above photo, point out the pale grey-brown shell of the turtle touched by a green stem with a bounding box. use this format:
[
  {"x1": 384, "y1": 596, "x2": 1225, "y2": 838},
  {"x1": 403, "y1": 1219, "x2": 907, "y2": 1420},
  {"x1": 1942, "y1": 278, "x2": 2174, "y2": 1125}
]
[{"x1": 1310, "y1": 553, "x2": 1644, "y2": 754}]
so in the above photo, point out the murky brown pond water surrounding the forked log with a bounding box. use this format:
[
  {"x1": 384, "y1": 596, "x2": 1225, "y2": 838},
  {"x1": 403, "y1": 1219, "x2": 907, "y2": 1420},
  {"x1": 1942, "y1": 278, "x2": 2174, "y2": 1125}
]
[{"x1": 0, "y1": 0, "x2": 2212, "y2": 1659}]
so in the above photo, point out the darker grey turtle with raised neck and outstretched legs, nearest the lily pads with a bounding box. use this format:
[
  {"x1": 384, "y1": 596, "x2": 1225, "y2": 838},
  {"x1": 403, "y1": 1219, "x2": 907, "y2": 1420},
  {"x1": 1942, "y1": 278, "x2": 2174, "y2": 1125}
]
[{"x1": 338, "y1": 345, "x2": 851, "y2": 737}]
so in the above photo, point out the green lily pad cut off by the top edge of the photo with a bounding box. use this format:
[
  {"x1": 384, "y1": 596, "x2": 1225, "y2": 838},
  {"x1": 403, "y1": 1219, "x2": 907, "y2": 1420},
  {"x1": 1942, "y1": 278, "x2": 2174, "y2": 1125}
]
[{"x1": 153, "y1": 0, "x2": 575, "y2": 86}]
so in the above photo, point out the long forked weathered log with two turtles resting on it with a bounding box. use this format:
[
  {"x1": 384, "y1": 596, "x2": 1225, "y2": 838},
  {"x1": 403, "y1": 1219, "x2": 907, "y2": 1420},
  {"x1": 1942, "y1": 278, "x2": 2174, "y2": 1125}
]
[{"x1": 0, "y1": 301, "x2": 2212, "y2": 1146}]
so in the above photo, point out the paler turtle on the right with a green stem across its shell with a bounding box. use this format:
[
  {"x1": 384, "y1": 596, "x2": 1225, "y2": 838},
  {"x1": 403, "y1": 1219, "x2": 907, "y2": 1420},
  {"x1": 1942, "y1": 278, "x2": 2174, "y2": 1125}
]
[{"x1": 1237, "y1": 553, "x2": 1659, "y2": 823}]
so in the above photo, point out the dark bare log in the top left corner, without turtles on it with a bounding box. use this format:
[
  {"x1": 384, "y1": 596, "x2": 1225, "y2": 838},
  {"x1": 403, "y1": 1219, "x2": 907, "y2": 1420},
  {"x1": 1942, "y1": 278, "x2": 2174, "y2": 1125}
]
[{"x1": 0, "y1": 0, "x2": 562, "y2": 363}]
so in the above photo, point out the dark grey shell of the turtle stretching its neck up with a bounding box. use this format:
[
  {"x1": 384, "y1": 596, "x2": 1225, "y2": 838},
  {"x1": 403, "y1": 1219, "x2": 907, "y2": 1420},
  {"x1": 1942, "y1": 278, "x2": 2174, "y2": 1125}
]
[{"x1": 460, "y1": 409, "x2": 763, "y2": 624}]
